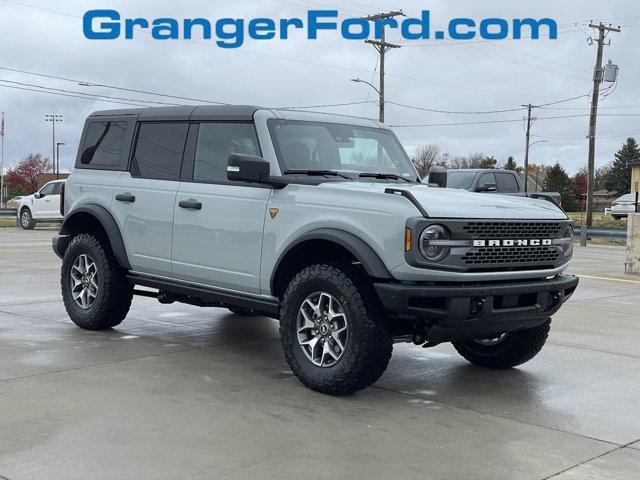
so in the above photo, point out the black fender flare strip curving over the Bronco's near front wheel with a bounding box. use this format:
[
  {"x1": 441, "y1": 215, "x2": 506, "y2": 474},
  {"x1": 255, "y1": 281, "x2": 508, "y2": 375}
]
[{"x1": 270, "y1": 227, "x2": 393, "y2": 292}]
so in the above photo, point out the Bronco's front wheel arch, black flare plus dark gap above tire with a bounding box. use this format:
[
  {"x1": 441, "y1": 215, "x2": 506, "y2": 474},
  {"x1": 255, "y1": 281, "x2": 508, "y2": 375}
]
[{"x1": 270, "y1": 228, "x2": 392, "y2": 297}]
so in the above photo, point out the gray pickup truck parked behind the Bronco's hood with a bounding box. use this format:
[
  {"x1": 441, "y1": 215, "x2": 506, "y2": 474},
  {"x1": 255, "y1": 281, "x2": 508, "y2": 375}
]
[{"x1": 438, "y1": 168, "x2": 560, "y2": 205}]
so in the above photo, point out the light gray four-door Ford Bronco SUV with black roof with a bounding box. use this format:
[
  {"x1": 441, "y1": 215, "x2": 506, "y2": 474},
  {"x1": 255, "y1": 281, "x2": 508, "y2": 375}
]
[{"x1": 53, "y1": 106, "x2": 578, "y2": 394}]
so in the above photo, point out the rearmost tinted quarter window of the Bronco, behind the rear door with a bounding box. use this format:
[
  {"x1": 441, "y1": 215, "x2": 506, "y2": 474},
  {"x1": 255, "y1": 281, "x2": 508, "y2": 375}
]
[{"x1": 80, "y1": 122, "x2": 127, "y2": 166}]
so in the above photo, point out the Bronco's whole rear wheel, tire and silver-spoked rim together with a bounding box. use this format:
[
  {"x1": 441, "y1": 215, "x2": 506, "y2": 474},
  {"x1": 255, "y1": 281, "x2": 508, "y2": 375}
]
[{"x1": 60, "y1": 233, "x2": 133, "y2": 330}]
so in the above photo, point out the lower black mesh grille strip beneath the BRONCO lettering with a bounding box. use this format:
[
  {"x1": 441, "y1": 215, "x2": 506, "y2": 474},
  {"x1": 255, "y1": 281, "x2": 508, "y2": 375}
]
[{"x1": 461, "y1": 245, "x2": 560, "y2": 266}]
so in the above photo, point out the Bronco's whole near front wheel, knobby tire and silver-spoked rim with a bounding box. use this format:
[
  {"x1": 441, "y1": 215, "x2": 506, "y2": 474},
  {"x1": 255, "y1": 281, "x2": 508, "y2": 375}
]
[{"x1": 280, "y1": 263, "x2": 393, "y2": 395}]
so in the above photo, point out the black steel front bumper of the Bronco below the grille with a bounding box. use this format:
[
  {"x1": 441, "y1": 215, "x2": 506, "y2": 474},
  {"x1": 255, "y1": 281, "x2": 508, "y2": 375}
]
[{"x1": 374, "y1": 275, "x2": 578, "y2": 341}]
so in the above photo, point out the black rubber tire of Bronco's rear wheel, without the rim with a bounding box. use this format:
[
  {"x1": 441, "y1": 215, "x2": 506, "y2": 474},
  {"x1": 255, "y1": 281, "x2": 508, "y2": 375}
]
[{"x1": 60, "y1": 233, "x2": 133, "y2": 330}]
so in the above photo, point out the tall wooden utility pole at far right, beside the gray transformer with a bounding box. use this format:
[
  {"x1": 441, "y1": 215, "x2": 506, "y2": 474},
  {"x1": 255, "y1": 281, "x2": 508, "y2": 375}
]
[{"x1": 586, "y1": 23, "x2": 620, "y2": 227}]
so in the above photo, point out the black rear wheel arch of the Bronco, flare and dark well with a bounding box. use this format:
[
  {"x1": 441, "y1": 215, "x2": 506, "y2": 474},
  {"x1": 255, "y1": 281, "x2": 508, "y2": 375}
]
[{"x1": 58, "y1": 204, "x2": 131, "y2": 270}]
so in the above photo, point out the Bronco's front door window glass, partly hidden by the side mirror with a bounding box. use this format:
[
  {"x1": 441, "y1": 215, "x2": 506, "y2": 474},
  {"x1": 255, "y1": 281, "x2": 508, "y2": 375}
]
[{"x1": 193, "y1": 123, "x2": 260, "y2": 182}]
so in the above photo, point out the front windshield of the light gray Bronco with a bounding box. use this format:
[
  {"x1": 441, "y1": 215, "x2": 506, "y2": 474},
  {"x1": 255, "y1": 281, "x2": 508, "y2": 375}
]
[{"x1": 268, "y1": 119, "x2": 417, "y2": 180}]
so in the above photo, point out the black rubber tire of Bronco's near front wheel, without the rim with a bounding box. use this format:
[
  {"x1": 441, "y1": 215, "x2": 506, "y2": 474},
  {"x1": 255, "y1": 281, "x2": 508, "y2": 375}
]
[{"x1": 280, "y1": 262, "x2": 393, "y2": 395}]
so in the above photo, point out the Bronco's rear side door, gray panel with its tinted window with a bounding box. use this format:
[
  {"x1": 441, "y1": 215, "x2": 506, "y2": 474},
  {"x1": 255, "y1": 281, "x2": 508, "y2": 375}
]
[{"x1": 111, "y1": 122, "x2": 188, "y2": 276}]
